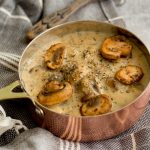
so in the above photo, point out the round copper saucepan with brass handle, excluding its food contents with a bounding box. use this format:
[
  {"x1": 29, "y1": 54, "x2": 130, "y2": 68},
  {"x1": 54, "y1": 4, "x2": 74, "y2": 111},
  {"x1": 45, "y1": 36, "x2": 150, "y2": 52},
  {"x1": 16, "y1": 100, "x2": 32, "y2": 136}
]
[{"x1": 0, "y1": 21, "x2": 150, "y2": 142}]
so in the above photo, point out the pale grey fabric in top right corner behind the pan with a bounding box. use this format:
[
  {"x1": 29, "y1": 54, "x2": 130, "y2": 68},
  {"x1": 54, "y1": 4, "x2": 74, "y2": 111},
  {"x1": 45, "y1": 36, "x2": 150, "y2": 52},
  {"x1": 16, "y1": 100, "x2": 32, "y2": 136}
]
[{"x1": 117, "y1": 0, "x2": 150, "y2": 49}]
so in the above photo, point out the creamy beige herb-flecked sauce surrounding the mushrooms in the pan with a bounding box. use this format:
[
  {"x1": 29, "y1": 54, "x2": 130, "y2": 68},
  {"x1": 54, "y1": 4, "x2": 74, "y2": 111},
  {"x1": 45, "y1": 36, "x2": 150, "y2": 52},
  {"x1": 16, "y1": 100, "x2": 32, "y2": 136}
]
[{"x1": 22, "y1": 31, "x2": 150, "y2": 116}]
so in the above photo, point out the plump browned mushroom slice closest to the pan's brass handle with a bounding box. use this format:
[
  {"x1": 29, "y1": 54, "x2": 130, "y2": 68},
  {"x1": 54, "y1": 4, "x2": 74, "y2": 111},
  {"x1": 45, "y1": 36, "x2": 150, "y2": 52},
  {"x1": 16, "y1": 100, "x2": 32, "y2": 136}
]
[{"x1": 37, "y1": 81, "x2": 73, "y2": 106}]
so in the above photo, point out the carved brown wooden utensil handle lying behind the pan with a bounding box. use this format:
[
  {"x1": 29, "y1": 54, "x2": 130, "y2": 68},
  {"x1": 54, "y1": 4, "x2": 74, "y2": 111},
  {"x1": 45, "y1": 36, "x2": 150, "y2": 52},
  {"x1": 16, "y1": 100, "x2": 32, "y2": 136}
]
[{"x1": 27, "y1": 0, "x2": 92, "y2": 40}]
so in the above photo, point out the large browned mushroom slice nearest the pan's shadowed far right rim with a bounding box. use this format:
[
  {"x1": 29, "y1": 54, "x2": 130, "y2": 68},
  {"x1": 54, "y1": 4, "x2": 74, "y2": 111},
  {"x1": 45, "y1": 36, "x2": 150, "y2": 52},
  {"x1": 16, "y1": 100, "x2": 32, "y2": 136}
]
[{"x1": 101, "y1": 35, "x2": 132, "y2": 60}]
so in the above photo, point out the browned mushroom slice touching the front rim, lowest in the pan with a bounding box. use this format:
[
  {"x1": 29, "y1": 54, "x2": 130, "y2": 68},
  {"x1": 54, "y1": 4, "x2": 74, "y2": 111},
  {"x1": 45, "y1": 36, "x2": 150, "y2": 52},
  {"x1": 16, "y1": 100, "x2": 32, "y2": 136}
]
[{"x1": 80, "y1": 94, "x2": 112, "y2": 116}]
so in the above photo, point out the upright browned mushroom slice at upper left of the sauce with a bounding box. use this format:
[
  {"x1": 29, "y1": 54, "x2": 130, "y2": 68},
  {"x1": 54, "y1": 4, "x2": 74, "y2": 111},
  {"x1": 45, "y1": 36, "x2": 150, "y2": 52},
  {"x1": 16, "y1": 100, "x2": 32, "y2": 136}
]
[{"x1": 44, "y1": 43, "x2": 65, "y2": 69}]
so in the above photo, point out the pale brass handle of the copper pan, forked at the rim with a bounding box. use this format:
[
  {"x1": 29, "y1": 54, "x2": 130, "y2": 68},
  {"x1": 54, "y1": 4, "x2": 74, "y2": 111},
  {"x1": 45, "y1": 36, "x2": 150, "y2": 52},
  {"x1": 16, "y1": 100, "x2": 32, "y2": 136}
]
[{"x1": 0, "y1": 80, "x2": 29, "y2": 101}]
